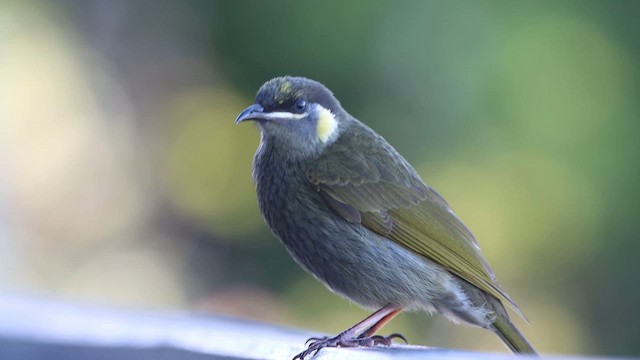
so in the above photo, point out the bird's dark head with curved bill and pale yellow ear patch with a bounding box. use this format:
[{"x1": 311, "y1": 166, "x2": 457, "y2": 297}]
[{"x1": 236, "y1": 76, "x2": 348, "y2": 156}]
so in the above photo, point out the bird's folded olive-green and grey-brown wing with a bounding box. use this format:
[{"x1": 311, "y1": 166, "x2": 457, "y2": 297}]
[{"x1": 307, "y1": 127, "x2": 524, "y2": 318}]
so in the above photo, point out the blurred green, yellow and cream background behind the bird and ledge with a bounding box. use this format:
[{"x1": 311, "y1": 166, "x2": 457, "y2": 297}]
[{"x1": 0, "y1": 0, "x2": 640, "y2": 355}]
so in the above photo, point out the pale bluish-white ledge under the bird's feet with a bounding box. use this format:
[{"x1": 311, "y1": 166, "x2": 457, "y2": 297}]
[{"x1": 0, "y1": 294, "x2": 624, "y2": 360}]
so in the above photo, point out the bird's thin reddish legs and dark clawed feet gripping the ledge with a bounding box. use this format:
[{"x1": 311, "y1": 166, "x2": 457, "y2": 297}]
[{"x1": 293, "y1": 305, "x2": 406, "y2": 360}]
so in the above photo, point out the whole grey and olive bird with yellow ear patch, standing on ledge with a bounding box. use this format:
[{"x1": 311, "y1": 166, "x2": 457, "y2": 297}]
[{"x1": 235, "y1": 76, "x2": 536, "y2": 360}]
